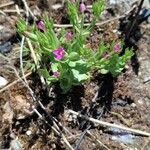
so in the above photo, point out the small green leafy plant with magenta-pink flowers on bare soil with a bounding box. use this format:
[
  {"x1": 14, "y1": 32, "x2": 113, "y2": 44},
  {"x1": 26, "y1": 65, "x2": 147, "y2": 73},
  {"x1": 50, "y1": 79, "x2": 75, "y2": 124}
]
[{"x1": 17, "y1": 0, "x2": 133, "y2": 92}]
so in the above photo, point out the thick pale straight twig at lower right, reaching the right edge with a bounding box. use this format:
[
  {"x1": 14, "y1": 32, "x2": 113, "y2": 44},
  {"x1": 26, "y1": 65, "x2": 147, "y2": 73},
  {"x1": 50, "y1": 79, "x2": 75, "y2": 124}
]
[{"x1": 69, "y1": 110, "x2": 150, "y2": 137}]
